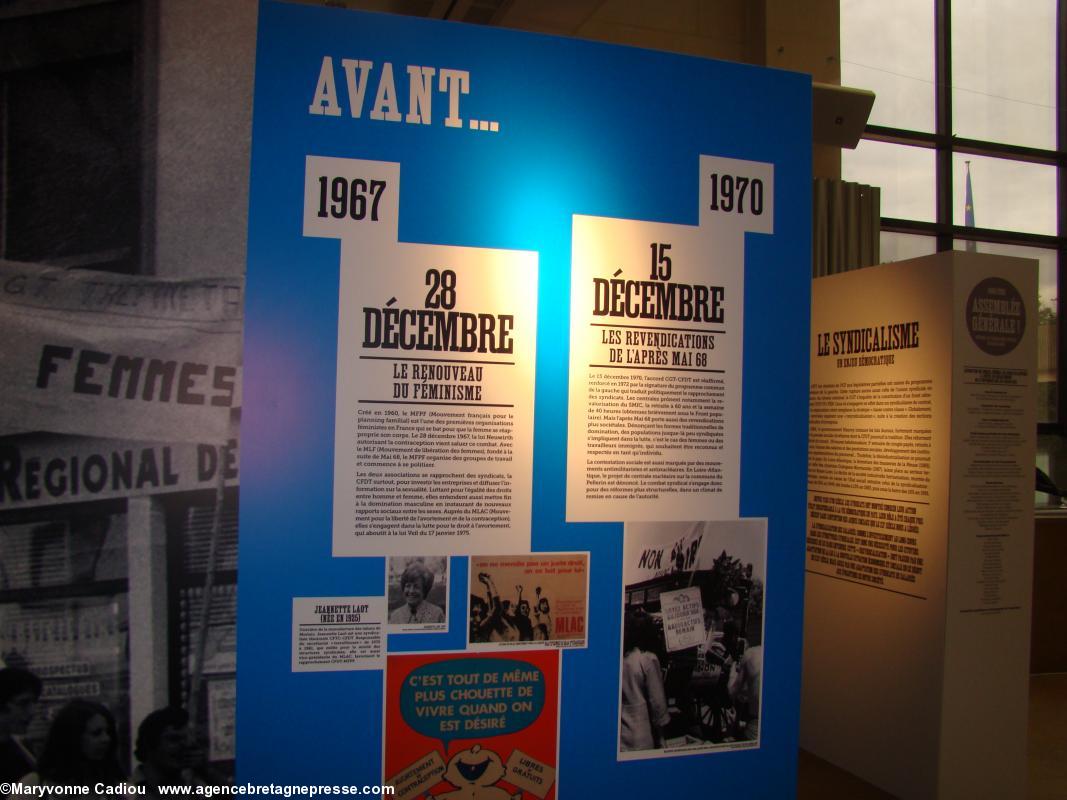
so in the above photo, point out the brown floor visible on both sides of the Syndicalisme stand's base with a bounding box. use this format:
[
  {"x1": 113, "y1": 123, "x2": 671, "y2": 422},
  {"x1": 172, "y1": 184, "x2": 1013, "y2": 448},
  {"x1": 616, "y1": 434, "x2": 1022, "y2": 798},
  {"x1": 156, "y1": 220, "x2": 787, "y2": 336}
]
[{"x1": 797, "y1": 673, "x2": 1067, "y2": 800}]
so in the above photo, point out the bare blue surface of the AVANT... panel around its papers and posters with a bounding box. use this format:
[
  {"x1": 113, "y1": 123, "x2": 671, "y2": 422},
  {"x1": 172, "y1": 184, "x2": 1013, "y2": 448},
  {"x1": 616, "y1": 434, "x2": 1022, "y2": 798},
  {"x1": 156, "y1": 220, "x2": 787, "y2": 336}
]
[{"x1": 237, "y1": 2, "x2": 811, "y2": 798}]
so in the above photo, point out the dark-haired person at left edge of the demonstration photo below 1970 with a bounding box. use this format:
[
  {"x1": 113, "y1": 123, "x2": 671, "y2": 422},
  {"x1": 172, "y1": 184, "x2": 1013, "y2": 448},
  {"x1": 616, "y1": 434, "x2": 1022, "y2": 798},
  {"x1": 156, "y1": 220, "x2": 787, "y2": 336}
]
[{"x1": 619, "y1": 610, "x2": 670, "y2": 751}]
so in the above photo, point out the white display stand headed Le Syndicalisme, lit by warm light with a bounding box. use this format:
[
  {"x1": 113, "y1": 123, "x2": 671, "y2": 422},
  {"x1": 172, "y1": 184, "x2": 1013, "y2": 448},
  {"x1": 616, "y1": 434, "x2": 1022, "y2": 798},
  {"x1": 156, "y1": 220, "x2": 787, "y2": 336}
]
[{"x1": 800, "y1": 252, "x2": 1038, "y2": 800}]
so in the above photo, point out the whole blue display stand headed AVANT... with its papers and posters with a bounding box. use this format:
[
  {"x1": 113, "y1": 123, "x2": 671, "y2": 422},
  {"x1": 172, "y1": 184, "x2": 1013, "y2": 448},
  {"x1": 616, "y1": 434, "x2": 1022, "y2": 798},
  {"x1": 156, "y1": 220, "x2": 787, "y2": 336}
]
[{"x1": 236, "y1": 2, "x2": 811, "y2": 800}]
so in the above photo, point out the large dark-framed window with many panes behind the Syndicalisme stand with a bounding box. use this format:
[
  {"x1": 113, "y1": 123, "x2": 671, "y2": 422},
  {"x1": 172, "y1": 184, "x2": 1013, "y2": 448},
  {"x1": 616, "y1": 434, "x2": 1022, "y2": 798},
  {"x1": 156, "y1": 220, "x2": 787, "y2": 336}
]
[{"x1": 841, "y1": 0, "x2": 1067, "y2": 448}]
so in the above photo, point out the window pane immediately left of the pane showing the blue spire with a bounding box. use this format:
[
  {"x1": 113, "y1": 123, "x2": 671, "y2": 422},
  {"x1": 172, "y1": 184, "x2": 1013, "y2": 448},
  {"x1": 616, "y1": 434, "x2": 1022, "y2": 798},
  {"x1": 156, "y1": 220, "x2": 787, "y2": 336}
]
[{"x1": 841, "y1": 140, "x2": 935, "y2": 222}]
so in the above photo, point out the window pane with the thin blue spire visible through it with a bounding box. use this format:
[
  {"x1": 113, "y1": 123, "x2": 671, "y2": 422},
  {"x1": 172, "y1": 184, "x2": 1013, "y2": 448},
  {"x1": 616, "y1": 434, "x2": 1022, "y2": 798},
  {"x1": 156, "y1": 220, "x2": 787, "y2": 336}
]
[{"x1": 951, "y1": 153, "x2": 1056, "y2": 236}]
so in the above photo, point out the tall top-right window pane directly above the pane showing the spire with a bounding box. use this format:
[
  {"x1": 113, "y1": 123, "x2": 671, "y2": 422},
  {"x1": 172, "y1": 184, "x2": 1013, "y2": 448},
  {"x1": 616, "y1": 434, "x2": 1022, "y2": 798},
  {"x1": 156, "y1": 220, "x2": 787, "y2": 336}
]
[{"x1": 952, "y1": 0, "x2": 1056, "y2": 149}]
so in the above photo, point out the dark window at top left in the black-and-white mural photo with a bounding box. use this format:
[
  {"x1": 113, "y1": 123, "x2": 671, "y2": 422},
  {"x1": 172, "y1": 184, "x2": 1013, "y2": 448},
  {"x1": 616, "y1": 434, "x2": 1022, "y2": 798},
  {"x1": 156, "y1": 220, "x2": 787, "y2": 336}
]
[{"x1": 0, "y1": 0, "x2": 143, "y2": 273}]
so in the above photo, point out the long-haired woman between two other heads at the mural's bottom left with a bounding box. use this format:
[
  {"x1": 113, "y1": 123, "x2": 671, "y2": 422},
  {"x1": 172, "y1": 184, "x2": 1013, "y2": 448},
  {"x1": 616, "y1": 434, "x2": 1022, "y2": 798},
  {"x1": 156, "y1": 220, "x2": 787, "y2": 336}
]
[{"x1": 21, "y1": 700, "x2": 126, "y2": 787}]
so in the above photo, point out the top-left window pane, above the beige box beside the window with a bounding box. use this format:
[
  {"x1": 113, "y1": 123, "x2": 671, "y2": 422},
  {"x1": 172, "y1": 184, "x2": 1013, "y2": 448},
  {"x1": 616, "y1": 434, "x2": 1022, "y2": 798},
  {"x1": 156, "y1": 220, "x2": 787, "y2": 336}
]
[{"x1": 841, "y1": 0, "x2": 934, "y2": 131}]
